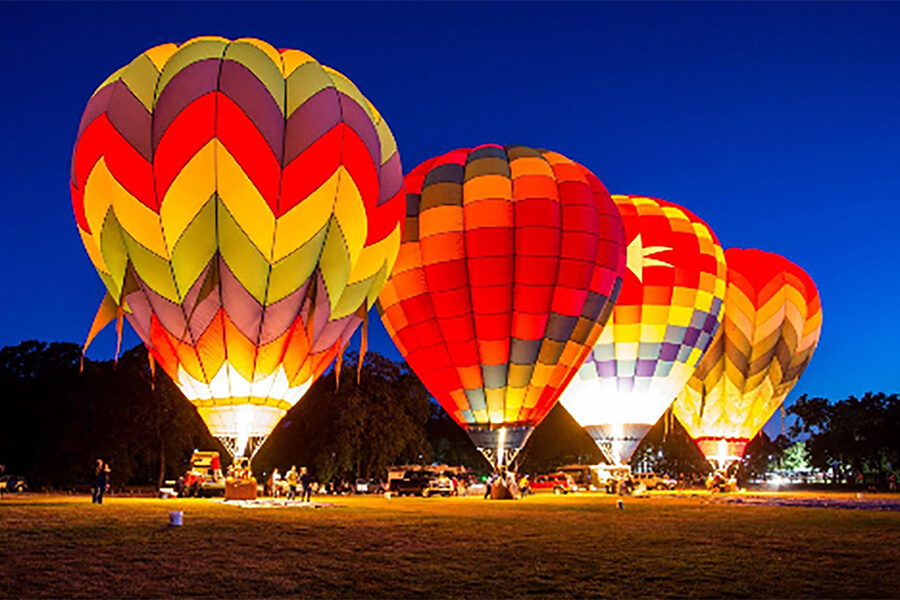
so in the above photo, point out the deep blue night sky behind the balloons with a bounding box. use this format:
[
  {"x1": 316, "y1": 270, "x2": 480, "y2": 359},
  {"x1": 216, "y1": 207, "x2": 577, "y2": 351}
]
[{"x1": 0, "y1": 2, "x2": 900, "y2": 436}]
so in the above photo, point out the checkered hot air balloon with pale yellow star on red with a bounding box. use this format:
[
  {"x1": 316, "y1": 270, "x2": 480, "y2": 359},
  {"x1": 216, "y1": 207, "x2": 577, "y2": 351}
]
[{"x1": 560, "y1": 196, "x2": 725, "y2": 464}]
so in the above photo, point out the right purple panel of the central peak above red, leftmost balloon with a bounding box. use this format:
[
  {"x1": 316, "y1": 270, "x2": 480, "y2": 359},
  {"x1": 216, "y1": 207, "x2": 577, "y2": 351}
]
[{"x1": 219, "y1": 60, "x2": 284, "y2": 163}]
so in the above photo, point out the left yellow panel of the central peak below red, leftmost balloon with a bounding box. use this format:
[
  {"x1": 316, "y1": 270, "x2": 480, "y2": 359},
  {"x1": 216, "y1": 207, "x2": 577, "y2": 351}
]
[{"x1": 159, "y1": 140, "x2": 218, "y2": 255}]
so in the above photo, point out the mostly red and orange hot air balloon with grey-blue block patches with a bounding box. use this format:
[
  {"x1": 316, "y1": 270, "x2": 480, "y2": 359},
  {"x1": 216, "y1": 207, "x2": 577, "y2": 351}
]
[{"x1": 378, "y1": 145, "x2": 625, "y2": 468}]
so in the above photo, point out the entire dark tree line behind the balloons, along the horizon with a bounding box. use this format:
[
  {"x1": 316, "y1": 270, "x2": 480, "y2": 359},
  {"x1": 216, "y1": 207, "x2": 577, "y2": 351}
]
[{"x1": 0, "y1": 341, "x2": 900, "y2": 489}]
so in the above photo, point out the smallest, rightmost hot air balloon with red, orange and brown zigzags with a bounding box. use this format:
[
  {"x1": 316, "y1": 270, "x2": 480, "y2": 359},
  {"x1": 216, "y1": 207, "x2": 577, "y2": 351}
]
[{"x1": 673, "y1": 248, "x2": 822, "y2": 468}]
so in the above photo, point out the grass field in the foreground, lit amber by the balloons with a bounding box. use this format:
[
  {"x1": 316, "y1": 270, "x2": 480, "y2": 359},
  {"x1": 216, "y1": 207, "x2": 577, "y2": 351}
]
[{"x1": 0, "y1": 494, "x2": 900, "y2": 598}]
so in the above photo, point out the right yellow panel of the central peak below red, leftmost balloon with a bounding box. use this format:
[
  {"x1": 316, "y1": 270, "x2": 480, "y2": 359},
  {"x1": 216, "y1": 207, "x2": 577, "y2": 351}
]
[{"x1": 216, "y1": 144, "x2": 275, "y2": 262}]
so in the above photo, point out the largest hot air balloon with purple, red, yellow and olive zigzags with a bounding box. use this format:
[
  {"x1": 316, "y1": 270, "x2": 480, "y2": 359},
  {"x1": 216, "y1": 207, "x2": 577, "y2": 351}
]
[{"x1": 71, "y1": 37, "x2": 404, "y2": 456}]
